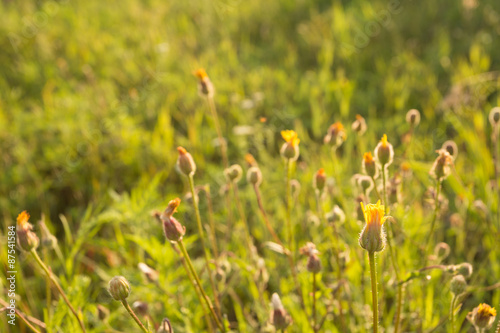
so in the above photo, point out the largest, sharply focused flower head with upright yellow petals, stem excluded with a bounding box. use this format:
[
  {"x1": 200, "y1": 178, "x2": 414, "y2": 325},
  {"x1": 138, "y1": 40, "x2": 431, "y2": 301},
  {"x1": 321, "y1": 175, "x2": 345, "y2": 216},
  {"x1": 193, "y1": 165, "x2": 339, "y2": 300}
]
[{"x1": 359, "y1": 200, "x2": 387, "y2": 252}]
